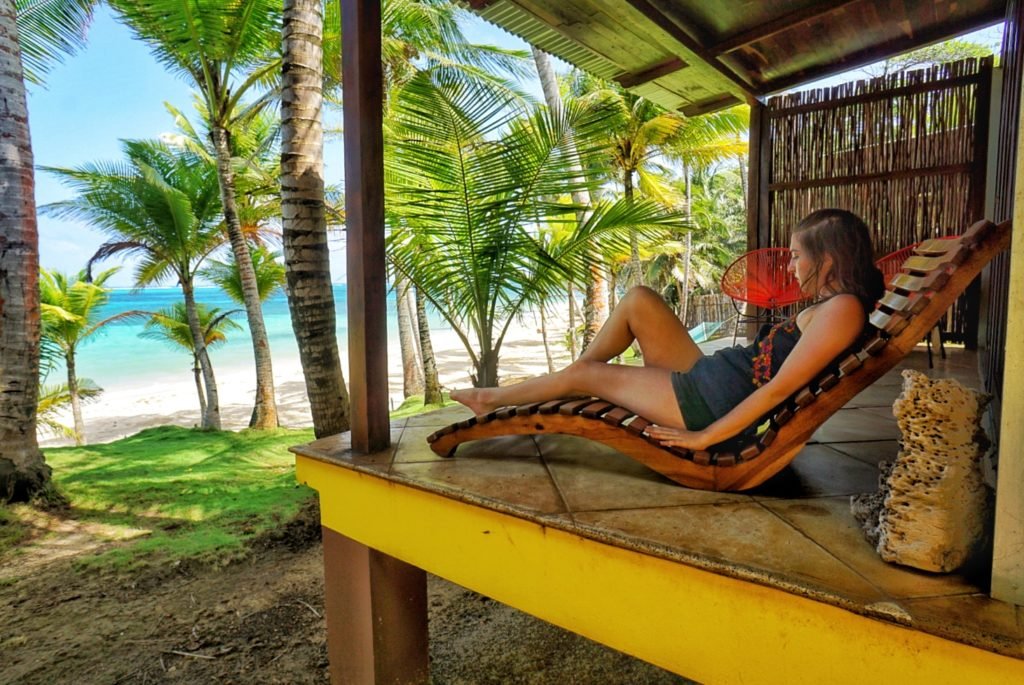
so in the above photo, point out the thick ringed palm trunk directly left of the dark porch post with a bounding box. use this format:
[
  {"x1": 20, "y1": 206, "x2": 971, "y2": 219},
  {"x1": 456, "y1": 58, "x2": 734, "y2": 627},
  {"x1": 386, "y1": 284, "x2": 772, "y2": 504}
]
[{"x1": 281, "y1": 0, "x2": 351, "y2": 437}]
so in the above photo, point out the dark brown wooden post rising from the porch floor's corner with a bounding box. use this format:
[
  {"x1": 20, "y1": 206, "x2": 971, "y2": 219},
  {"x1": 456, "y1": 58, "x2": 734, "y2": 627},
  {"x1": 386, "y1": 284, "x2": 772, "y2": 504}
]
[{"x1": 341, "y1": 0, "x2": 390, "y2": 453}]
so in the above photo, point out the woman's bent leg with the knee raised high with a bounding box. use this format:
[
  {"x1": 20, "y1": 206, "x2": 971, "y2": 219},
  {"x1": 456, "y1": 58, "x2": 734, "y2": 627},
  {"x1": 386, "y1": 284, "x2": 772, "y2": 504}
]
[{"x1": 580, "y1": 287, "x2": 703, "y2": 371}]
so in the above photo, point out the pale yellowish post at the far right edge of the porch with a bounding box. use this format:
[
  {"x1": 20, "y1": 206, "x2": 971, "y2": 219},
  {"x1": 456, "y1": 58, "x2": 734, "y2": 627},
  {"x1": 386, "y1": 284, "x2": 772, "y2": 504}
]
[{"x1": 992, "y1": 73, "x2": 1024, "y2": 605}]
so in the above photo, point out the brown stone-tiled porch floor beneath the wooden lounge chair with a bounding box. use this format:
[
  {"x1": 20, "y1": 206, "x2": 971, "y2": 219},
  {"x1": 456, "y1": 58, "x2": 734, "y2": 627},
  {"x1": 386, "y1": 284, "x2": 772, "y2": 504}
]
[{"x1": 298, "y1": 348, "x2": 1024, "y2": 658}]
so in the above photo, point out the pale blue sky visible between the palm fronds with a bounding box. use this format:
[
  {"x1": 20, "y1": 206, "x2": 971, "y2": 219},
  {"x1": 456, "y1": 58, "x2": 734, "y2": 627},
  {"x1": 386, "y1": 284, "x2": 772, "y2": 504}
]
[{"x1": 29, "y1": 7, "x2": 1001, "y2": 287}]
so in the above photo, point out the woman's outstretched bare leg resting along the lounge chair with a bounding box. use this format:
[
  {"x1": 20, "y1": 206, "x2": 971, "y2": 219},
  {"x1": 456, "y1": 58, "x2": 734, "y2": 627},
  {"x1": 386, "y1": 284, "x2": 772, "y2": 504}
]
[{"x1": 452, "y1": 358, "x2": 684, "y2": 428}]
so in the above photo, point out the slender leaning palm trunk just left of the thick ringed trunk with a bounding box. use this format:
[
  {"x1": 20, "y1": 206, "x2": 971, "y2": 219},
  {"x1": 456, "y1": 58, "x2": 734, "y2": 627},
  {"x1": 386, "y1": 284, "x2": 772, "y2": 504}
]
[{"x1": 210, "y1": 124, "x2": 284, "y2": 429}]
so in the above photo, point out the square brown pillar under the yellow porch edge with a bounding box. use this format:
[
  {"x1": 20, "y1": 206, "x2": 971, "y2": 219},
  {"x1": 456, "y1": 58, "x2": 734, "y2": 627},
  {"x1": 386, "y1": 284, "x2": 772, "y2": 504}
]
[{"x1": 323, "y1": 527, "x2": 428, "y2": 685}]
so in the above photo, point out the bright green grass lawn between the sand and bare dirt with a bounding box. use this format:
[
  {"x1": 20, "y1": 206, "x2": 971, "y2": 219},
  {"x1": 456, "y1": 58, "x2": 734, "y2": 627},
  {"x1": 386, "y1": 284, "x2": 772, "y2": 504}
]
[{"x1": 0, "y1": 396, "x2": 452, "y2": 569}]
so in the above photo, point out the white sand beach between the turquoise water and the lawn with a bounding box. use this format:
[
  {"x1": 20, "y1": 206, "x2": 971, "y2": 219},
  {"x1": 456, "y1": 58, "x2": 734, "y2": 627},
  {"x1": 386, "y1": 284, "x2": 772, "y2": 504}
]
[{"x1": 39, "y1": 316, "x2": 569, "y2": 447}]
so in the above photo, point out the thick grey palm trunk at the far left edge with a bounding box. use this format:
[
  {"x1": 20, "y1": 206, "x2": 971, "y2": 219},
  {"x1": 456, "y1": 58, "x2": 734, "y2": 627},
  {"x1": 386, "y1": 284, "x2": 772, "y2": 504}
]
[{"x1": 0, "y1": 0, "x2": 50, "y2": 502}]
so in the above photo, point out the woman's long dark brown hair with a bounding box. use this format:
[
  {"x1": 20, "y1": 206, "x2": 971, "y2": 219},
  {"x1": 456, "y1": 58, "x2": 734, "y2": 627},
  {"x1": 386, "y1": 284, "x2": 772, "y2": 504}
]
[{"x1": 793, "y1": 209, "x2": 886, "y2": 312}]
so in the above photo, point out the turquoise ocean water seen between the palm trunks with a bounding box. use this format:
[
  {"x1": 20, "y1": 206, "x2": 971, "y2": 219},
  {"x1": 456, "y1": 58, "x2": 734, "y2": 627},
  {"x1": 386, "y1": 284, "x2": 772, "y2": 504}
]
[{"x1": 55, "y1": 285, "x2": 419, "y2": 390}]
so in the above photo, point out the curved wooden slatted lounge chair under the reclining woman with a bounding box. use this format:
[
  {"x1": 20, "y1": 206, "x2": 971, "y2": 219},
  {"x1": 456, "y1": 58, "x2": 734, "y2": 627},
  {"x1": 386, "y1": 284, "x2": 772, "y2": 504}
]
[{"x1": 427, "y1": 216, "x2": 1011, "y2": 490}]
